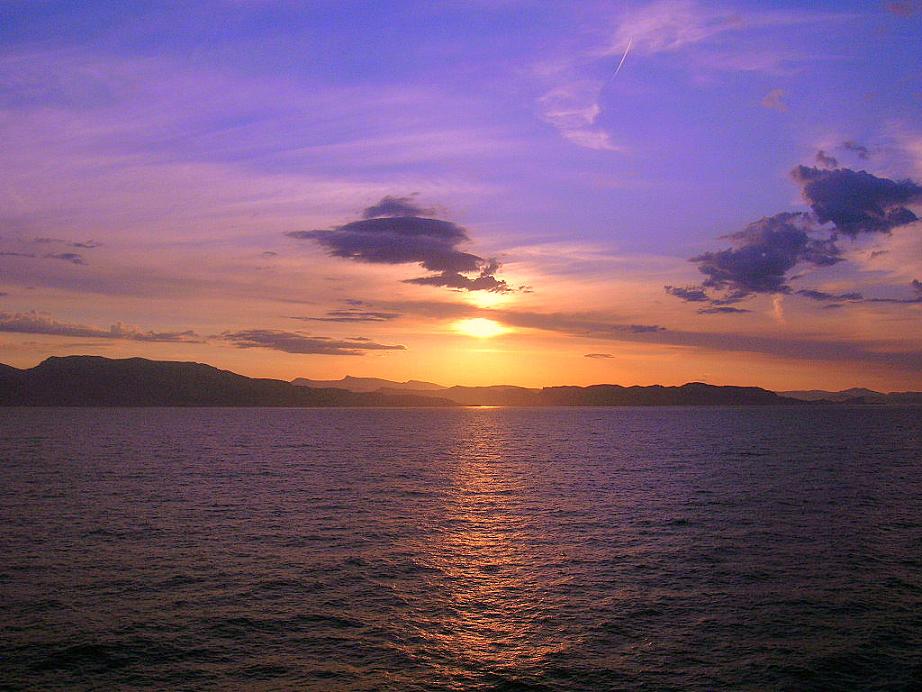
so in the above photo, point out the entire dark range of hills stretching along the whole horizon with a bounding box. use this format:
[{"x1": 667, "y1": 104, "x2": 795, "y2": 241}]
[{"x1": 0, "y1": 356, "x2": 922, "y2": 407}]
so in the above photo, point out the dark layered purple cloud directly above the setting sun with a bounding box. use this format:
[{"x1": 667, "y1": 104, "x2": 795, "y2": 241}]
[{"x1": 285, "y1": 197, "x2": 512, "y2": 293}]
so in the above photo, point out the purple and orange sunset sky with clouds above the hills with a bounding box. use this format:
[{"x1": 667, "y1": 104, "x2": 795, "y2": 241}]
[{"x1": 0, "y1": 0, "x2": 922, "y2": 391}]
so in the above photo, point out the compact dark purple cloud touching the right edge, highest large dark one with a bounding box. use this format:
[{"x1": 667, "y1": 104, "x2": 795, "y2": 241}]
[{"x1": 791, "y1": 166, "x2": 922, "y2": 237}]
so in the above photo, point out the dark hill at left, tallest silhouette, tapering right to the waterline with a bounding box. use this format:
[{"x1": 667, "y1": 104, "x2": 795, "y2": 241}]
[{"x1": 0, "y1": 356, "x2": 455, "y2": 406}]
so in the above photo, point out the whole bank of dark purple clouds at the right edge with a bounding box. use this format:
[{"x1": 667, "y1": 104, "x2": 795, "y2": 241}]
[{"x1": 665, "y1": 164, "x2": 922, "y2": 314}]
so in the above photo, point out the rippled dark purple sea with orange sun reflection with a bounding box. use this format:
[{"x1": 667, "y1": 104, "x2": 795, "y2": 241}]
[{"x1": 0, "y1": 407, "x2": 922, "y2": 690}]
